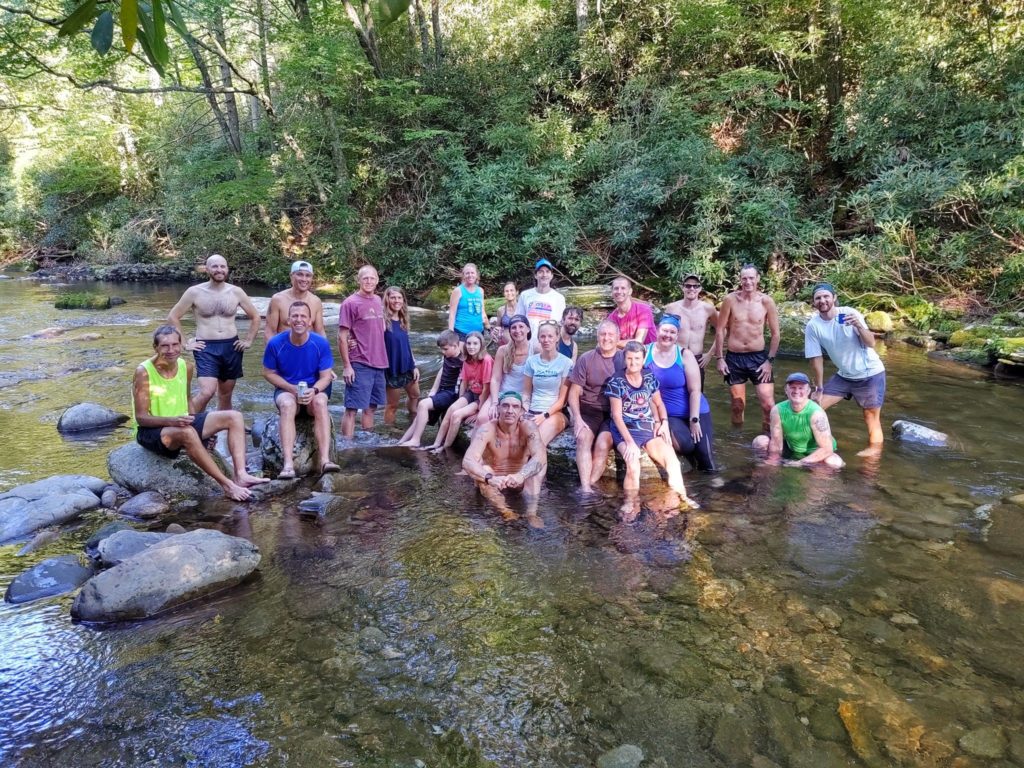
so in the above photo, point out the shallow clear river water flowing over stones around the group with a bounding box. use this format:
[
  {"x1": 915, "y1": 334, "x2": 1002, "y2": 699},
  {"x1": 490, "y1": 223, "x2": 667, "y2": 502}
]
[{"x1": 0, "y1": 280, "x2": 1024, "y2": 768}]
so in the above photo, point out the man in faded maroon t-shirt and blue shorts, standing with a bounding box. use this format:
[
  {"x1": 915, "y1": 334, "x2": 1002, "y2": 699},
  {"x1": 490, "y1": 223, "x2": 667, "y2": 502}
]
[{"x1": 338, "y1": 264, "x2": 387, "y2": 437}]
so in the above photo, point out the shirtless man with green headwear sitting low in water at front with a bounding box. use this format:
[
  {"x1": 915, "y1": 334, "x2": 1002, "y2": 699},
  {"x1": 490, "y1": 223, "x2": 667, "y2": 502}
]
[{"x1": 462, "y1": 392, "x2": 548, "y2": 526}]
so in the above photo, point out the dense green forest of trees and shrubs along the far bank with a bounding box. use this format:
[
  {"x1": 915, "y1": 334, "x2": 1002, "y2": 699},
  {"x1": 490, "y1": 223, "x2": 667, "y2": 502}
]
[{"x1": 0, "y1": 0, "x2": 1024, "y2": 319}]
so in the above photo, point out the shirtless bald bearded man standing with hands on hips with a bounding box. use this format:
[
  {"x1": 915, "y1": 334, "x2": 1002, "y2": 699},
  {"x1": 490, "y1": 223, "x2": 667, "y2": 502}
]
[{"x1": 167, "y1": 253, "x2": 260, "y2": 413}]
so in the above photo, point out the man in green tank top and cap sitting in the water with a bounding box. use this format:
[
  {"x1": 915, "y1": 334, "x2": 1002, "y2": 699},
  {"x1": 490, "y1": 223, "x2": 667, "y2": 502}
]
[{"x1": 754, "y1": 372, "x2": 844, "y2": 469}]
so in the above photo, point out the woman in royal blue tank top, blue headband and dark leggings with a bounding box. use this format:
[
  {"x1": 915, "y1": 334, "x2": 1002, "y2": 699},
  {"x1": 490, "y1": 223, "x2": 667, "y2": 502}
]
[{"x1": 644, "y1": 314, "x2": 715, "y2": 472}]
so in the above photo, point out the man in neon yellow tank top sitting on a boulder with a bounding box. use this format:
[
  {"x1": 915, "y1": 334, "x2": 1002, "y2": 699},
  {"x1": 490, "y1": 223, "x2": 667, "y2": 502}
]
[{"x1": 132, "y1": 326, "x2": 270, "y2": 502}]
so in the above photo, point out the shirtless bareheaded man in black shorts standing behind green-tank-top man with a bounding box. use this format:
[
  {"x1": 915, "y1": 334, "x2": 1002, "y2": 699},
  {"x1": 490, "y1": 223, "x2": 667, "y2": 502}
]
[{"x1": 715, "y1": 264, "x2": 781, "y2": 432}]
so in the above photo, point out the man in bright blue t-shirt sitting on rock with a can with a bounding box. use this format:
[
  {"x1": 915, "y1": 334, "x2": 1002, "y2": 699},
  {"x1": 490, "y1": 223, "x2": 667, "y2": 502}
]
[{"x1": 263, "y1": 301, "x2": 340, "y2": 479}]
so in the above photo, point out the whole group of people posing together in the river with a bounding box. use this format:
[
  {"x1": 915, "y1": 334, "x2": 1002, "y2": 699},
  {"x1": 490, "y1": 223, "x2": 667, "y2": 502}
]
[{"x1": 133, "y1": 254, "x2": 885, "y2": 516}]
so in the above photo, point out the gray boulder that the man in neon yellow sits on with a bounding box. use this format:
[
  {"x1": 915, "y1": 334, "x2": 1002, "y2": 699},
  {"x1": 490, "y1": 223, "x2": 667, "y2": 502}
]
[{"x1": 106, "y1": 441, "x2": 224, "y2": 499}]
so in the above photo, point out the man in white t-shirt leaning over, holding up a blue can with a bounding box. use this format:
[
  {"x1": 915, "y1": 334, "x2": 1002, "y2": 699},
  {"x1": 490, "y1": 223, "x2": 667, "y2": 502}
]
[{"x1": 804, "y1": 283, "x2": 886, "y2": 456}]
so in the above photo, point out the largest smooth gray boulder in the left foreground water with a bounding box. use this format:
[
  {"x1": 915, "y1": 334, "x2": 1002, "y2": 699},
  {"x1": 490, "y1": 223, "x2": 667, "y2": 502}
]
[{"x1": 71, "y1": 529, "x2": 260, "y2": 622}]
